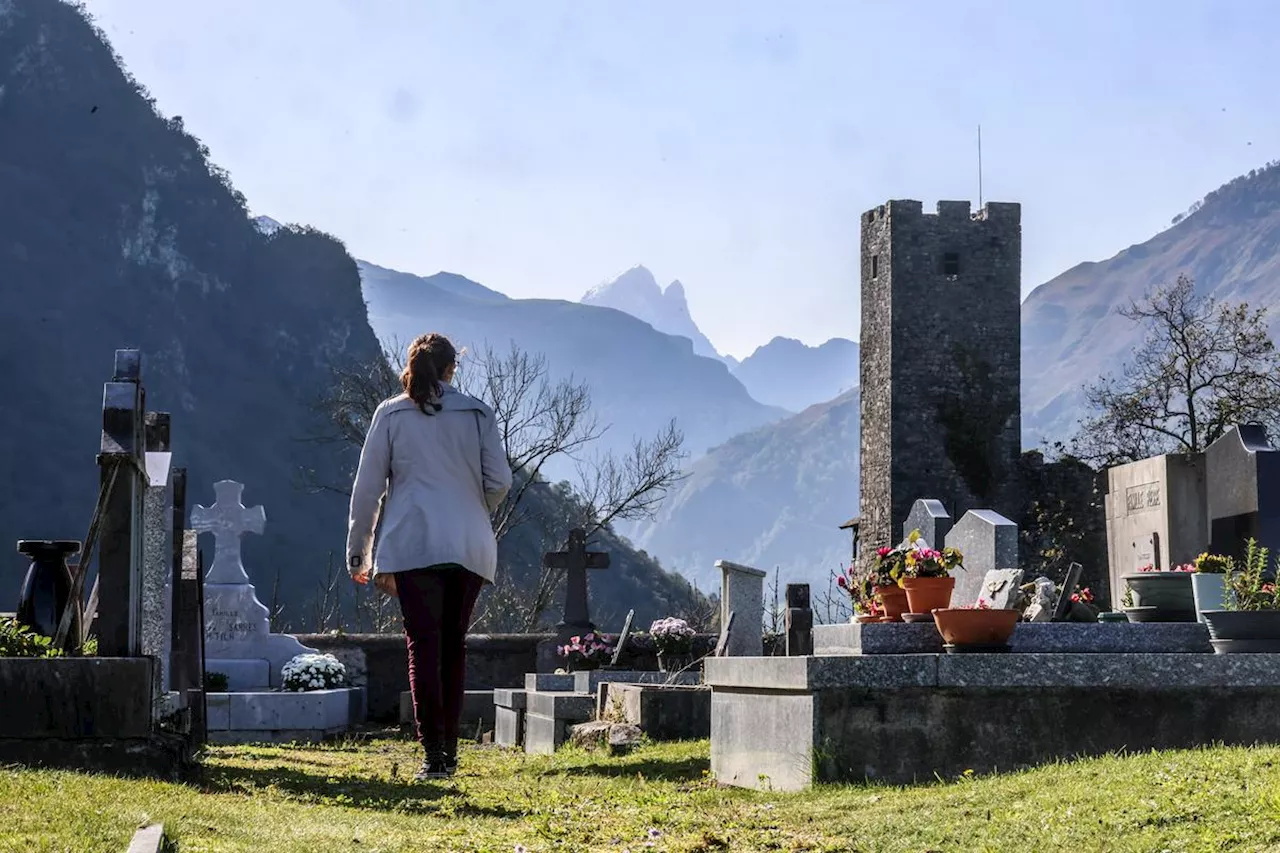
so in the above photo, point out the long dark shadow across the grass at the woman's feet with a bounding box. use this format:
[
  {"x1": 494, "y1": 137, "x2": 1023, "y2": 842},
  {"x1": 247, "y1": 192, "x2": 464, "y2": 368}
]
[{"x1": 195, "y1": 766, "x2": 526, "y2": 818}]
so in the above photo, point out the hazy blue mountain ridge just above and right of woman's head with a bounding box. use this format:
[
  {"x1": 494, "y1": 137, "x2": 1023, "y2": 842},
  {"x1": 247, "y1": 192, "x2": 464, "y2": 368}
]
[{"x1": 360, "y1": 261, "x2": 786, "y2": 476}]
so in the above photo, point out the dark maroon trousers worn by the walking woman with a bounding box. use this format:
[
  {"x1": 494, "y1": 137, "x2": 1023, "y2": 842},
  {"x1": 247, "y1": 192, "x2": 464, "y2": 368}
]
[{"x1": 396, "y1": 565, "x2": 484, "y2": 756}]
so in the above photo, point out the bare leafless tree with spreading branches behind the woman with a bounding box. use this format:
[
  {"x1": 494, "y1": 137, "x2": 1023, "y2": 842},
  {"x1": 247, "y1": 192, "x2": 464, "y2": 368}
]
[{"x1": 306, "y1": 335, "x2": 684, "y2": 631}]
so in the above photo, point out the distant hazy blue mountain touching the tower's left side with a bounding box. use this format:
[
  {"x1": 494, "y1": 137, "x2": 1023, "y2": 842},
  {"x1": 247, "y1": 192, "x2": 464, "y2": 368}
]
[{"x1": 733, "y1": 338, "x2": 860, "y2": 411}]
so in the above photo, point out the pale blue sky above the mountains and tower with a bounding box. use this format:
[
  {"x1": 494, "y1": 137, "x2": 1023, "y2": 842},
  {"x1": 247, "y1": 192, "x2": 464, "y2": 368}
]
[{"x1": 86, "y1": 0, "x2": 1280, "y2": 356}]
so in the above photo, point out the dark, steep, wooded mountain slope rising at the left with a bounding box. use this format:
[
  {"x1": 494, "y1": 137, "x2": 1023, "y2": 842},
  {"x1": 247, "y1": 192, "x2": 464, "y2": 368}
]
[{"x1": 0, "y1": 0, "x2": 706, "y2": 628}]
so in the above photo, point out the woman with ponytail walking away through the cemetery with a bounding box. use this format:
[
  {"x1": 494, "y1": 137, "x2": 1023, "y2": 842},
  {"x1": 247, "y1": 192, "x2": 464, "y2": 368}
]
[{"x1": 347, "y1": 334, "x2": 511, "y2": 780}]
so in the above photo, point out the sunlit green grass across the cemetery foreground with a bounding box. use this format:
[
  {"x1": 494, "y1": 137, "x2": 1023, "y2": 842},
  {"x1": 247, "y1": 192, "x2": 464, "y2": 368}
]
[{"x1": 0, "y1": 739, "x2": 1280, "y2": 853}]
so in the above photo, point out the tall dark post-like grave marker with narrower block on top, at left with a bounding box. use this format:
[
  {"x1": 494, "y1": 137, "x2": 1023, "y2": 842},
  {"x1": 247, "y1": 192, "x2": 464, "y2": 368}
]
[{"x1": 96, "y1": 350, "x2": 146, "y2": 657}]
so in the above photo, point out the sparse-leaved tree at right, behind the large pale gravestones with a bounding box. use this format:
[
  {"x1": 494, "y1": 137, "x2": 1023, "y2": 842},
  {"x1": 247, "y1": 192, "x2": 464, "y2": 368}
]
[{"x1": 1071, "y1": 275, "x2": 1280, "y2": 466}]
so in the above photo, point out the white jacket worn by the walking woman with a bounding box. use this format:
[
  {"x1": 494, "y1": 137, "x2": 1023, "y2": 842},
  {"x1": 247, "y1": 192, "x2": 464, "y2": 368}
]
[{"x1": 347, "y1": 383, "x2": 511, "y2": 583}]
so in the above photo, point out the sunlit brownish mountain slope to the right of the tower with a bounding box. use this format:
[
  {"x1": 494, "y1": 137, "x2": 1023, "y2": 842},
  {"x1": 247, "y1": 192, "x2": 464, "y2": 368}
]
[{"x1": 1023, "y1": 164, "x2": 1280, "y2": 448}]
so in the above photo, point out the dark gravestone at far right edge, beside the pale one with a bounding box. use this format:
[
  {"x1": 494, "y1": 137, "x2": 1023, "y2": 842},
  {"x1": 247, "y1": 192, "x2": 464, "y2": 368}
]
[{"x1": 1204, "y1": 424, "x2": 1280, "y2": 558}]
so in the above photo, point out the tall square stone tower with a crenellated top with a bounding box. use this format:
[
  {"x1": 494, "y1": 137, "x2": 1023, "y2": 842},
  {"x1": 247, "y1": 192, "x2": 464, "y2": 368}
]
[{"x1": 860, "y1": 201, "x2": 1023, "y2": 555}]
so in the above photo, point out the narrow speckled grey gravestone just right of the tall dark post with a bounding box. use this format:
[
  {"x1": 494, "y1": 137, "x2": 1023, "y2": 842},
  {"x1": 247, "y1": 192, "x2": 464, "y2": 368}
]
[{"x1": 141, "y1": 412, "x2": 174, "y2": 694}]
